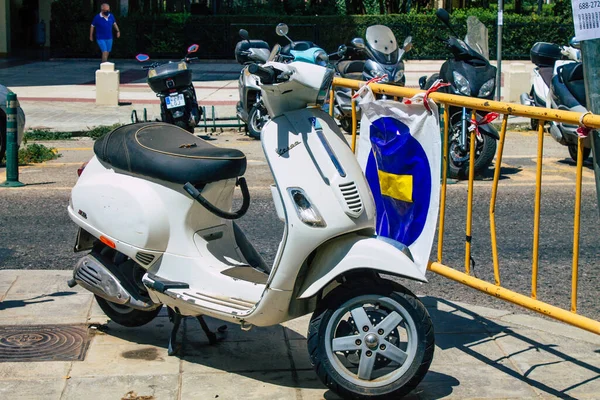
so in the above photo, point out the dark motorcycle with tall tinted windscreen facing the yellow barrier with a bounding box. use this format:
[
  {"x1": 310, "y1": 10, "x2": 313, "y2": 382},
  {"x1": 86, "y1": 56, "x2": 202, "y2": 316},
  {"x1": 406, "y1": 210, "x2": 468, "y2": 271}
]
[{"x1": 419, "y1": 8, "x2": 500, "y2": 179}]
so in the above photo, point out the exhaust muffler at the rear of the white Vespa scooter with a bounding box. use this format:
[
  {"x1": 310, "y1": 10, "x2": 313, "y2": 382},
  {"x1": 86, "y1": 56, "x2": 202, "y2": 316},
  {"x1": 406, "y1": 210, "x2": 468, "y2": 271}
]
[{"x1": 73, "y1": 254, "x2": 158, "y2": 310}]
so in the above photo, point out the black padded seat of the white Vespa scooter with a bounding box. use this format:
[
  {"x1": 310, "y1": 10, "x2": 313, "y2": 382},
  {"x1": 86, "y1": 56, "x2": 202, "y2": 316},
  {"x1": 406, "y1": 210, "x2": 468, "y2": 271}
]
[{"x1": 94, "y1": 122, "x2": 246, "y2": 185}]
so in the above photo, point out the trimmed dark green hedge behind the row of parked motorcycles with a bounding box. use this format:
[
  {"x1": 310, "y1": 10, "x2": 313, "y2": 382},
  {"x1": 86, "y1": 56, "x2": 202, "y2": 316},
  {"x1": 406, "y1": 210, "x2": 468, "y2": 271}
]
[{"x1": 51, "y1": 0, "x2": 573, "y2": 59}]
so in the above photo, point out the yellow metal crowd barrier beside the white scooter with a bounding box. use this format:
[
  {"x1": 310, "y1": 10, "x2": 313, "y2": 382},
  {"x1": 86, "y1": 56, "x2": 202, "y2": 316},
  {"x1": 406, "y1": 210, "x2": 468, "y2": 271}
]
[{"x1": 330, "y1": 78, "x2": 600, "y2": 334}]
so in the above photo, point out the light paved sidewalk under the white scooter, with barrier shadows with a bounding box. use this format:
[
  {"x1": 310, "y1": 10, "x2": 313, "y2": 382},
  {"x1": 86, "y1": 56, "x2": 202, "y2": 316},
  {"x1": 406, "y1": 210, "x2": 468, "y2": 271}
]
[{"x1": 0, "y1": 270, "x2": 600, "y2": 400}]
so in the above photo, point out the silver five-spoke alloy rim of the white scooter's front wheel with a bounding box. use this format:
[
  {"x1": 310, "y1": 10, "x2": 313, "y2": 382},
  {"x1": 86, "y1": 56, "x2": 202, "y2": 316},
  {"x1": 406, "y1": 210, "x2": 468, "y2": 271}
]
[{"x1": 325, "y1": 294, "x2": 418, "y2": 388}]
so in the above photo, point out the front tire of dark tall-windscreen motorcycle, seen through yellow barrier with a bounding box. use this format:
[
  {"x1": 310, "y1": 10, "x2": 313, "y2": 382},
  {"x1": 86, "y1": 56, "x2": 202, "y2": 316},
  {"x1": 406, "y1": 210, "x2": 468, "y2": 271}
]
[{"x1": 448, "y1": 123, "x2": 497, "y2": 179}]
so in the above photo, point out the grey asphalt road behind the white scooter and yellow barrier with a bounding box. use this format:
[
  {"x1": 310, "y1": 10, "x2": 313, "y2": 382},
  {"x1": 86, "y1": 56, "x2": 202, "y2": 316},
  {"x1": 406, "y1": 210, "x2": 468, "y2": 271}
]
[{"x1": 0, "y1": 132, "x2": 600, "y2": 319}]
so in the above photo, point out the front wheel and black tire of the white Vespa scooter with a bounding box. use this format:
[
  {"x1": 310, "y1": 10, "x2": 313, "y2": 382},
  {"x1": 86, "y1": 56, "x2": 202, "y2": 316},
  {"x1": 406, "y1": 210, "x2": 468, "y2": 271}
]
[{"x1": 308, "y1": 281, "x2": 434, "y2": 399}]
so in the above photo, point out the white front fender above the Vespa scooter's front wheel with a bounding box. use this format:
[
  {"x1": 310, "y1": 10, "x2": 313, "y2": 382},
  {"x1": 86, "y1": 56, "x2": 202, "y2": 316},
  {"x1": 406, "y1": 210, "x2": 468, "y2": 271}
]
[{"x1": 298, "y1": 233, "x2": 427, "y2": 299}]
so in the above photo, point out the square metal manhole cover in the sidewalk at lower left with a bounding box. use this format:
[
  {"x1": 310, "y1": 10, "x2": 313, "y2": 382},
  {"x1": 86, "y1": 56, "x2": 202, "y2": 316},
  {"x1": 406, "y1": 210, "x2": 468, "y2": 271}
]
[{"x1": 0, "y1": 325, "x2": 90, "y2": 362}]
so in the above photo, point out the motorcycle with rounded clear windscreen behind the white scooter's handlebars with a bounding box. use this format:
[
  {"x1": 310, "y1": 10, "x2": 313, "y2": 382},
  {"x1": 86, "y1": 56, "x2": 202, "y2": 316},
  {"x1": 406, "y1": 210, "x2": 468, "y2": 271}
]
[{"x1": 334, "y1": 25, "x2": 413, "y2": 133}]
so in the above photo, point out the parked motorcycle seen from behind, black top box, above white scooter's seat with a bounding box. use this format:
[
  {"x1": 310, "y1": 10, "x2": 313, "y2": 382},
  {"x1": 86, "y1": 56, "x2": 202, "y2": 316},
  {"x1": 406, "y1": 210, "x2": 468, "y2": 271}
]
[{"x1": 135, "y1": 44, "x2": 202, "y2": 133}]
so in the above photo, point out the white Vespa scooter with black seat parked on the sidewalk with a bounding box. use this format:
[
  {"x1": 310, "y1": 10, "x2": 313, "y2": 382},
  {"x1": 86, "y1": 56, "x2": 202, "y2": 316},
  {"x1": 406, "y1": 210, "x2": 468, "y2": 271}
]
[{"x1": 68, "y1": 44, "x2": 434, "y2": 399}]
